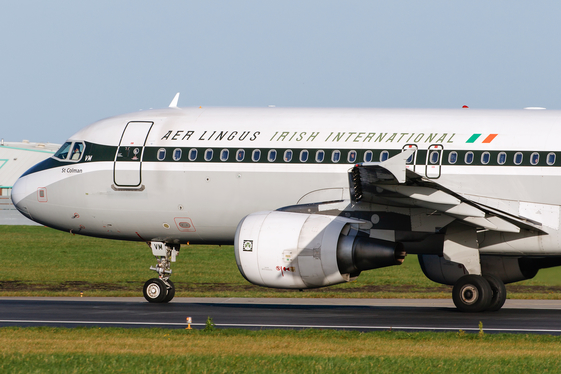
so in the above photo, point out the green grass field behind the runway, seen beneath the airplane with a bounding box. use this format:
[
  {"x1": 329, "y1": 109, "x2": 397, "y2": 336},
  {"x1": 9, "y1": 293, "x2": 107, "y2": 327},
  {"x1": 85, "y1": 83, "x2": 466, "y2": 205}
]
[{"x1": 0, "y1": 226, "x2": 561, "y2": 299}]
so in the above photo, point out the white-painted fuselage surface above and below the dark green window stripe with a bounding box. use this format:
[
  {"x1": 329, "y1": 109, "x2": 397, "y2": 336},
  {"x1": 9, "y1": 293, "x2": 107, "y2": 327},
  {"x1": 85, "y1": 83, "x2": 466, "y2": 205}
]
[{"x1": 12, "y1": 108, "x2": 561, "y2": 254}]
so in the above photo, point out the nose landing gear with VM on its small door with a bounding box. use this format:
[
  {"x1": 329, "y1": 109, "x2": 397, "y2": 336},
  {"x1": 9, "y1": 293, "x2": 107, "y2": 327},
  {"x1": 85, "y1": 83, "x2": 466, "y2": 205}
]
[{"x1": 143, "y1": 242, "x2": 179, "y2": 303}]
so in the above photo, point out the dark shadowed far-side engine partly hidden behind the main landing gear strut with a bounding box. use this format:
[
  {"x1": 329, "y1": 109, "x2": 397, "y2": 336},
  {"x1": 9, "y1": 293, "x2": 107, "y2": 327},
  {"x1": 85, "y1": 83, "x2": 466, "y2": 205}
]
[{"x1": 419, "y1": 255, "x2": 545, "y2": 285}]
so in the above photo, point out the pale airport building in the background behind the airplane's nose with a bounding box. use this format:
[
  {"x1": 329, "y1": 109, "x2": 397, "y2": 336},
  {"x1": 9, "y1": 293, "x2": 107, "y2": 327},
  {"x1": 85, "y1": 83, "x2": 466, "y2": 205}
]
[{"x1": 0, "y1": 139, "x2": 60, "y2": 225}]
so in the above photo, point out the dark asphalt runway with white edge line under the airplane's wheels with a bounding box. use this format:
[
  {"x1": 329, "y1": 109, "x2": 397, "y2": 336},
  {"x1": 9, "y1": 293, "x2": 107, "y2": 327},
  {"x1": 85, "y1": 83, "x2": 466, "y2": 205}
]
[{"x1": 0, "y1": 297, "x2": 561, "y2": 335}]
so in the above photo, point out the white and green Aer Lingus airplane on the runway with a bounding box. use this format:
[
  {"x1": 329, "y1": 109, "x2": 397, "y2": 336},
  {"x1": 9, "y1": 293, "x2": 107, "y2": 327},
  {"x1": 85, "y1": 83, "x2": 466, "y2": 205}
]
[{"x1": 8, "y1": 94, "x2": 561, "y2": 312}]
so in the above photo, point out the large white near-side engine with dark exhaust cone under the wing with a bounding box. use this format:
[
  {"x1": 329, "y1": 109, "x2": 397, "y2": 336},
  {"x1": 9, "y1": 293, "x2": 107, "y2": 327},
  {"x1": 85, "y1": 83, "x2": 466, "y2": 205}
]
[{"x1": 234, "y1": 211, "x2": 405, "y2": 289}]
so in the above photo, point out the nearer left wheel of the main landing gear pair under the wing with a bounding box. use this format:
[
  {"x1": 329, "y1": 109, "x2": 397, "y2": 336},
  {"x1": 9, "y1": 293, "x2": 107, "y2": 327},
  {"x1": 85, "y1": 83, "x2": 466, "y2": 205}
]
[{"x1": 452, "y1": 274, "x2": 493, "y2": 313}]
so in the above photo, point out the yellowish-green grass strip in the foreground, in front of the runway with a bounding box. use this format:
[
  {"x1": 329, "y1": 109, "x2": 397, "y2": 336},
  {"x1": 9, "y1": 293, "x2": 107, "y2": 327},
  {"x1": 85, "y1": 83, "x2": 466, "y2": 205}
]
[{"x1": 0, "y1": 327, "x2": 561, "y2": 373}]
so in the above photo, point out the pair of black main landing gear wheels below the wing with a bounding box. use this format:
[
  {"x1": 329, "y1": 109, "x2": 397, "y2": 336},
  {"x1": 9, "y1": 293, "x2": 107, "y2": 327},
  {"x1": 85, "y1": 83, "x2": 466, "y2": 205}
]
[{"x1": 452, "y1": 274, "x2": 506, "y2": 313}]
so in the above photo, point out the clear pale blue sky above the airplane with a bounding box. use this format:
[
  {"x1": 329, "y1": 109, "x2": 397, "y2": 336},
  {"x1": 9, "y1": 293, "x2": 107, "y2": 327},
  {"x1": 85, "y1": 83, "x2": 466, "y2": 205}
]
[{"x1": 0, "y1": 0, "x2": 561, "y2": 143}]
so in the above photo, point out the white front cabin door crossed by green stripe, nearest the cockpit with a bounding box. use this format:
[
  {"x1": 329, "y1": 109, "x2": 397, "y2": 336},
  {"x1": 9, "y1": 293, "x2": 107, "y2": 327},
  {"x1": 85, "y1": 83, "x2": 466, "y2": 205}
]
[{"x1": 113, "y1": 122, "x2": 154, "y2": 187}]
